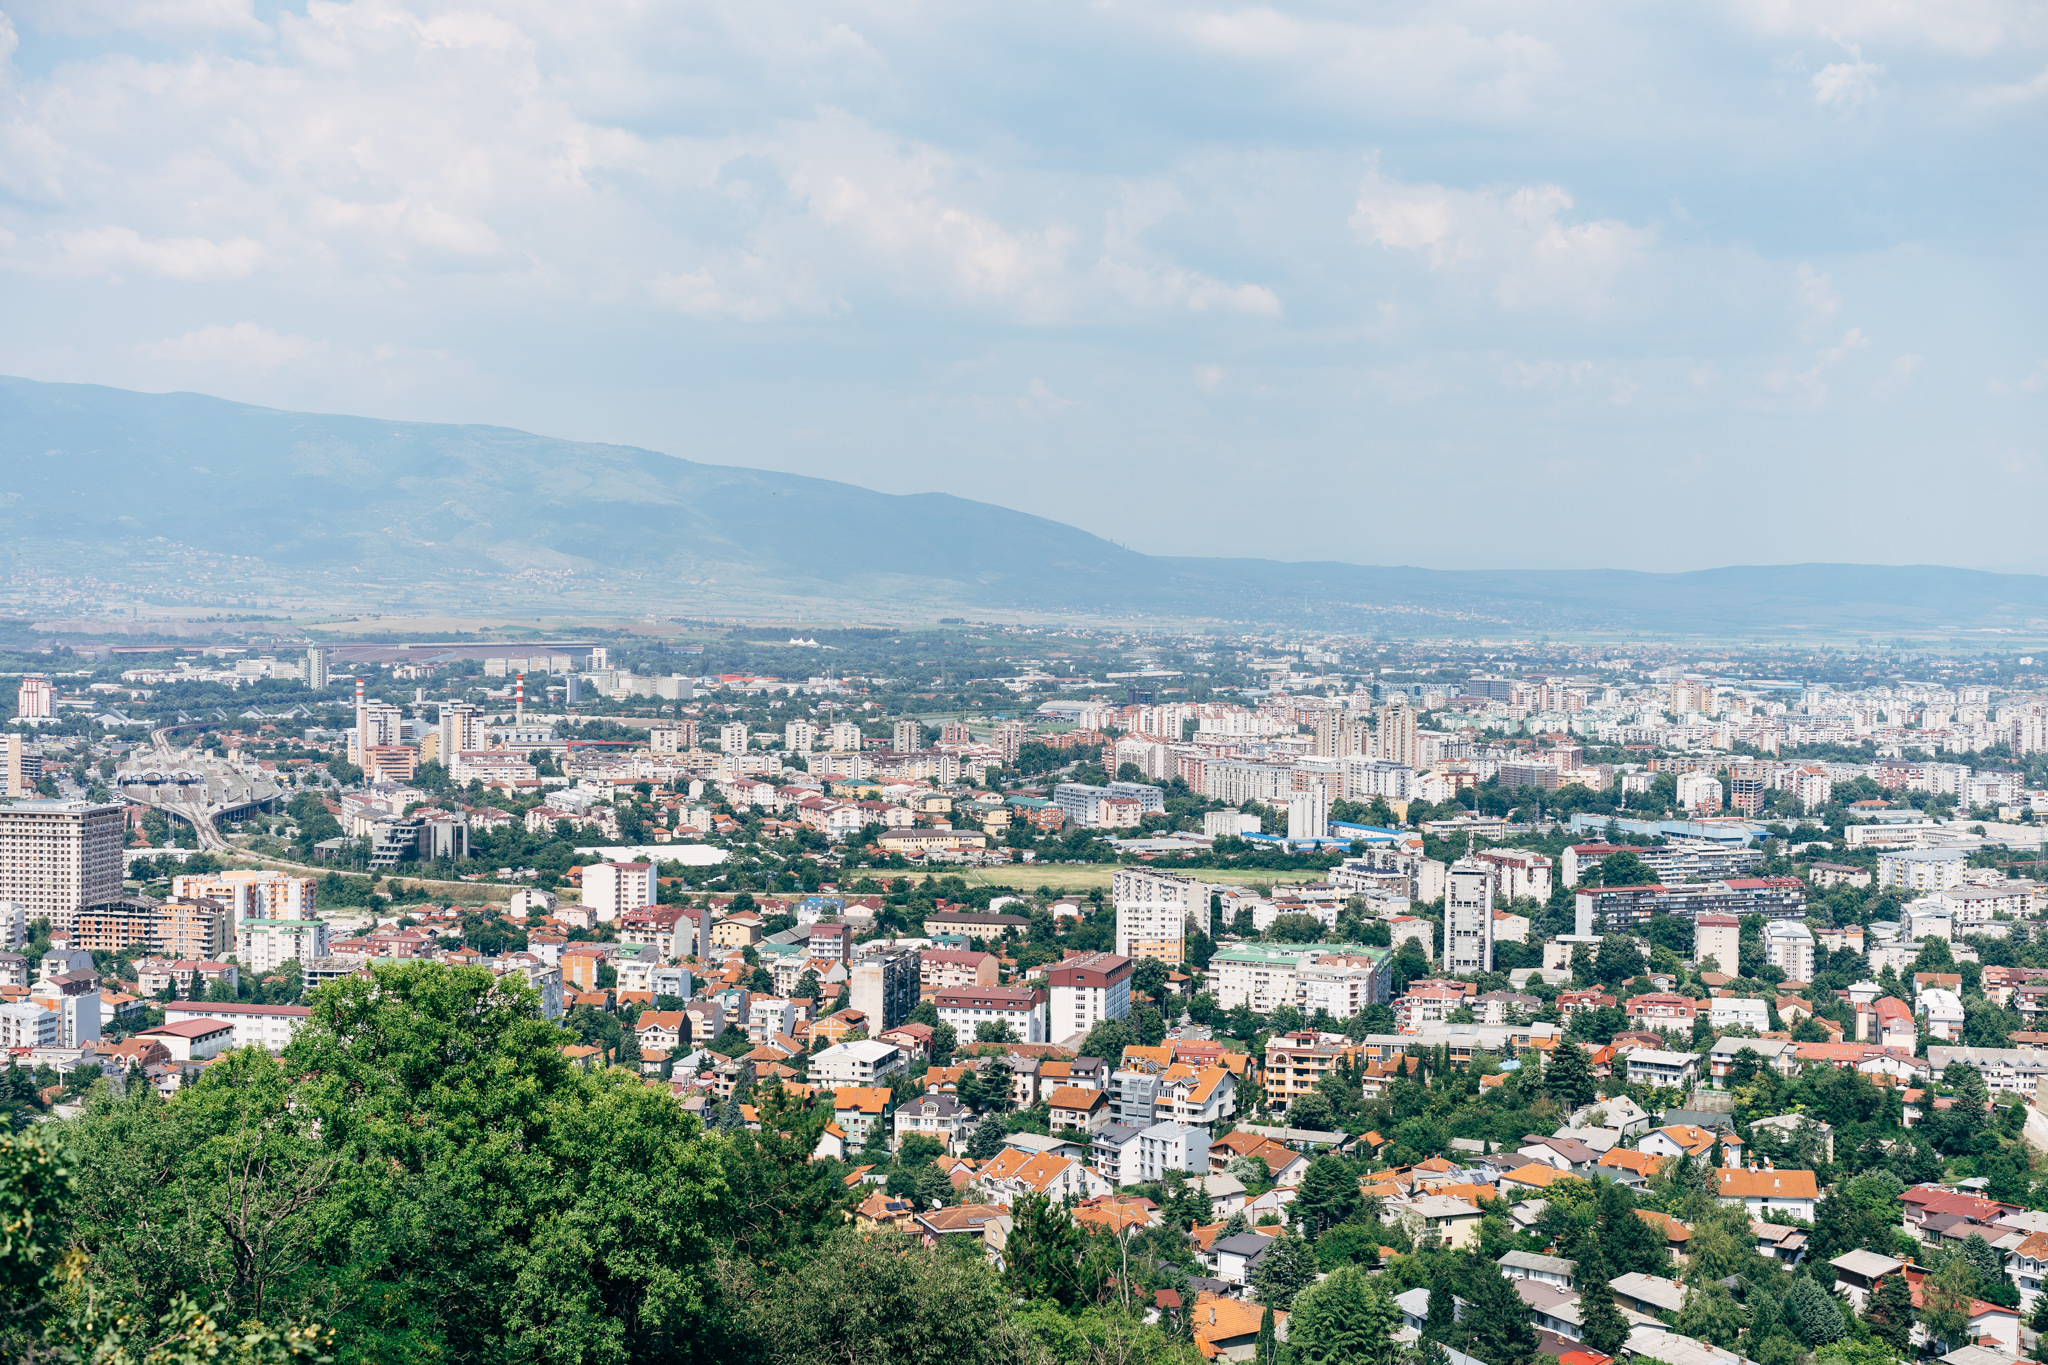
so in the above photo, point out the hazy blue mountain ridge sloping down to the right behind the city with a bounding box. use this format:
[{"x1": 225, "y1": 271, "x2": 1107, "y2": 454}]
[{"x1": 0, "y1": 379, "x2": 2048, "y2": 636}]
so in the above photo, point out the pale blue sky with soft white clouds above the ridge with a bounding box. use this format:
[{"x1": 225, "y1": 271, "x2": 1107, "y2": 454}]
[{"x1": 0, "y1": 0, "x2": 2048, "y2": 573}]
